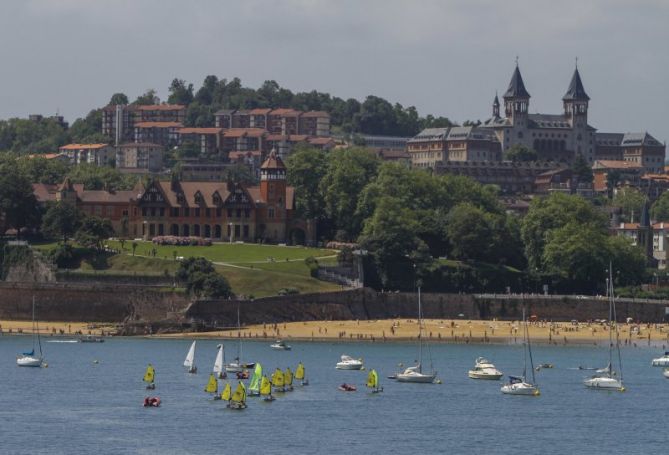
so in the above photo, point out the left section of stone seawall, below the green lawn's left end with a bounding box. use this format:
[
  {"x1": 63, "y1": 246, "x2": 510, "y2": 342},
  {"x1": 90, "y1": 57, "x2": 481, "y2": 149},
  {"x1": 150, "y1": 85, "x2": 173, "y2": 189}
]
[{"x1": 0, "y1": 283, "x2": 189, "y2": 322}]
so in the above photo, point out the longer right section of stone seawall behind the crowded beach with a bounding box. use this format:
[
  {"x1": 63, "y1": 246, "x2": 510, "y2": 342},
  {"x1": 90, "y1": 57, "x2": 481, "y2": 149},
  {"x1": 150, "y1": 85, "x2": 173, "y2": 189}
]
[{"x1": 186, "y1": 289, "x2": 669, "y2": 327}]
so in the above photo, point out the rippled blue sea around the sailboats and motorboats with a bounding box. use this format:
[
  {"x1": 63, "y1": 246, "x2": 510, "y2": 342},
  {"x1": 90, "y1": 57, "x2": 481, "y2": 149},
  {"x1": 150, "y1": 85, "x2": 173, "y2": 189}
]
[{"x1": 0, "y1": 336, "x2": 669, "y2": 455}]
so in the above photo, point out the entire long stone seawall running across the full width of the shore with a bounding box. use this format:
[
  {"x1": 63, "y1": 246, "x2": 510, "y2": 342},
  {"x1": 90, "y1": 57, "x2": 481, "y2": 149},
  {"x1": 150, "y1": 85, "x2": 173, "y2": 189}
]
[{"x1": 0, "y1": 282, "x2": 669, "y2": 327}]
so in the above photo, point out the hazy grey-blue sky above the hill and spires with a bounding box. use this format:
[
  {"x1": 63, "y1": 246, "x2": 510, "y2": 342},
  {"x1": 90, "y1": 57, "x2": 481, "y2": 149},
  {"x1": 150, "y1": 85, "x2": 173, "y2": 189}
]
[{"x1": 0, "y1": 0, "x2": 669, "y2": 141}]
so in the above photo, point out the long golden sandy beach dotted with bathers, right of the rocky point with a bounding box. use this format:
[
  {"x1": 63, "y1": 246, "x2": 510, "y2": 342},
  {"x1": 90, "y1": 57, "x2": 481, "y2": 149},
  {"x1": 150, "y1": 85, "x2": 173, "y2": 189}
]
[{"x1": 157, "y1": 319, "x2": 669, "y2": 345}]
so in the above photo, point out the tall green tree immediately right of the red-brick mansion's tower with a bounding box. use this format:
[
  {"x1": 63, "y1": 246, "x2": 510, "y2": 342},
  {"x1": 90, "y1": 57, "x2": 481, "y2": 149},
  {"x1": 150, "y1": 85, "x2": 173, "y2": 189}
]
[{"x1": 286, "y1": 145, "x2": 328, "y2": 219}]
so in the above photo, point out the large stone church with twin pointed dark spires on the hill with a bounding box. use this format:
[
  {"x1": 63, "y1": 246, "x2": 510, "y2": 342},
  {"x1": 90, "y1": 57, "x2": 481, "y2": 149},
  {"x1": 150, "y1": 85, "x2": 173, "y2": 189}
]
[{"x1": 481, "y1": 62, "x2": 596, "y2": 164}]
